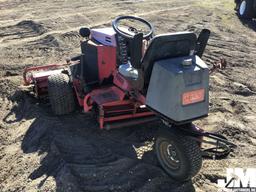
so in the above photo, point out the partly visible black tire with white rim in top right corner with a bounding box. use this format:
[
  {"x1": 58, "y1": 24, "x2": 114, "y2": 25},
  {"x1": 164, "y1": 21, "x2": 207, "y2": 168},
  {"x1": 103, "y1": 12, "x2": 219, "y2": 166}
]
[{"x1": 237, "y1": 0, "x2": 256, "y2": 19}]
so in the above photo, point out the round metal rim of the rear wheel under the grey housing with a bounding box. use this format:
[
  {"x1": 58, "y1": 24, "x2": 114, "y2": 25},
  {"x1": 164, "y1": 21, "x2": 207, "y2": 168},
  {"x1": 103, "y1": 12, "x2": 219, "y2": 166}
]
[{"x1": 159, "y1": 141, "x2": 180, "y2": 170}]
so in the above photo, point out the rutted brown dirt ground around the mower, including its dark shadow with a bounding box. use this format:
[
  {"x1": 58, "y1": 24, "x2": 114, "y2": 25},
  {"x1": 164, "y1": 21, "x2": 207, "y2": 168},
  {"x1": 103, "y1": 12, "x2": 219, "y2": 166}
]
[{"x1": 0, "y1": 0, "x2": 256, "y2": 192}]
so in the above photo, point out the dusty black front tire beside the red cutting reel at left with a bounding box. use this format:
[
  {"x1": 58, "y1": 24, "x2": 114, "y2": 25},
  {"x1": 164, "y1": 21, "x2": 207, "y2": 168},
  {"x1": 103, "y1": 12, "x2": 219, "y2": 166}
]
[{"x1": 48, "y1": 73, "x2": 76, "y2": 115}]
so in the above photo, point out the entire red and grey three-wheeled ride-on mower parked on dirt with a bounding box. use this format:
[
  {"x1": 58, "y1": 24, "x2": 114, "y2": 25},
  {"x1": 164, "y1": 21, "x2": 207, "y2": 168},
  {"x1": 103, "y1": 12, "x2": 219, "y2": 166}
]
[{"x1": 24, "y1": 16, "x2": 234, "y2": 181}]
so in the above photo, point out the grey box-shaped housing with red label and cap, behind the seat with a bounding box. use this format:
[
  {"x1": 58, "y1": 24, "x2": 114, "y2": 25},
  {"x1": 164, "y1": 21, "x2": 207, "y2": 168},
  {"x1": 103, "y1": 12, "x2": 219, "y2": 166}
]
[{"x1": 146, "y1": 56, "x2": 209, "y2": 123}]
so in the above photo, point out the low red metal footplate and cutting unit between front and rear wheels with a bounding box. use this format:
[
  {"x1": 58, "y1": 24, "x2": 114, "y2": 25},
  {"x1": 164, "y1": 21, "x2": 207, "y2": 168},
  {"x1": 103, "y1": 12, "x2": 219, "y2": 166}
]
[{"x1": 75, "y1": 82, "x2": 155, "y2": 129}]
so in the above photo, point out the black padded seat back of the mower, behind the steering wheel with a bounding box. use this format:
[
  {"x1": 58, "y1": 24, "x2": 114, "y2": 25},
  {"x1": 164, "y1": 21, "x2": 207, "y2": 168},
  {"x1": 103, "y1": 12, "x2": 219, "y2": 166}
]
[{"x1": 142, "y1": 32, "x2": 197, "y2": 89}]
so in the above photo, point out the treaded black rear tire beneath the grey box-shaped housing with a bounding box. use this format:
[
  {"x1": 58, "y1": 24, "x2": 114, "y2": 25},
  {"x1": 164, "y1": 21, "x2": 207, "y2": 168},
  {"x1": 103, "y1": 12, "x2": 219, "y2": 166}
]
[{"x1": 155, "y1": 130, "x2": 202, "y2": 182}]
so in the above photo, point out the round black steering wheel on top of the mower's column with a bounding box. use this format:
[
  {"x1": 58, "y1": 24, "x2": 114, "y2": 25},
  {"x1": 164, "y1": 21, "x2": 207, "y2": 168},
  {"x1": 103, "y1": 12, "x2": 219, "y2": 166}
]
[{"x1": 112, "y1": 16, "x2": 154, "y2": 40}]
